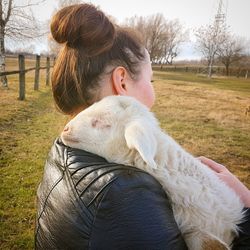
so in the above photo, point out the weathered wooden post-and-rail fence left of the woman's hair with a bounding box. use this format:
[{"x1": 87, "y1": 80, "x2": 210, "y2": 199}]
[{"x1": 0, "y1": 55, "x2": 53, "y2": 100}]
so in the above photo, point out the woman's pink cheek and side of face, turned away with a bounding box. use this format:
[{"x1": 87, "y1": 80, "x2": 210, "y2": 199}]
[{"x1": 128, "y1": 51, "x2": 155, "y2": 108}]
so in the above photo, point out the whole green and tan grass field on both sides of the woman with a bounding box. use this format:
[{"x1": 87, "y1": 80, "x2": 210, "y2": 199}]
[{"x1": 0, "y1": 61, "x2": 250, "y2": 249}]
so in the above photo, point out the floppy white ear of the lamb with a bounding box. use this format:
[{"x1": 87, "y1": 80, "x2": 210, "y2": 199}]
[{"x1": 125, "y1": 121, "x2": 157, "y2": 169}]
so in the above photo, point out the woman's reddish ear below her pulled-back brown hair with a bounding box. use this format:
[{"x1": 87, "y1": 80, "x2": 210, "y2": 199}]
[{"x1": 111, "y1": 66, "x2": 128, "y2": 95}]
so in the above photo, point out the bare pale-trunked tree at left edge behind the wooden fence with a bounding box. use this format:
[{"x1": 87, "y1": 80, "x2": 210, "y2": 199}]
[{"x1": 0, "y1": 0, "x2": 45, "y2": 87}]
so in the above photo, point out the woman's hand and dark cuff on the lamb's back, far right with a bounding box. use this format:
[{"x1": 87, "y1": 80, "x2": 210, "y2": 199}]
[{"x1": 199, "y1": 156, "x2": 250, "y2": 250}]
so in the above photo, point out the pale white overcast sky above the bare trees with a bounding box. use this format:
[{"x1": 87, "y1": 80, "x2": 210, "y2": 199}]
[{"x1": 28, "y1": 0, "x2": 250, "y2": 59}]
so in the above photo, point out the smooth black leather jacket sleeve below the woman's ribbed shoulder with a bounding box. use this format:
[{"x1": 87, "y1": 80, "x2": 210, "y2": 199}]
[{"x1": 89, "y1": 171, "x2": 187, "y2": 250}]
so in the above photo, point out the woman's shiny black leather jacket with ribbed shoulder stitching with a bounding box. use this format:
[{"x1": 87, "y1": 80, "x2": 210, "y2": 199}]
[{"x1": 35, "y1": 139, "x2": 249, "y2": 250}]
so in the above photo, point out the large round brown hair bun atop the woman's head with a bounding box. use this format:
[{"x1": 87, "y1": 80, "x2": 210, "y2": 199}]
[{"x1": 50, "y1": 4, "x2": 115, "y2": 55}]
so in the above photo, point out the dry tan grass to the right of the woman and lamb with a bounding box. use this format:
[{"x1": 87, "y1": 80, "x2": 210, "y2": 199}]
[{"x1": 154, "y1": 72, "x2": 250, "y2": 187}]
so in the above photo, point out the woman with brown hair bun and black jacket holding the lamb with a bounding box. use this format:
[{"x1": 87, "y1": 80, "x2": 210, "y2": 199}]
[{"x1": 35, "y1": 4, "x2": 250, "y2": 249}]
